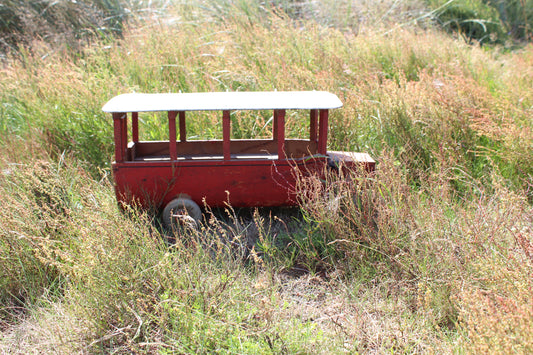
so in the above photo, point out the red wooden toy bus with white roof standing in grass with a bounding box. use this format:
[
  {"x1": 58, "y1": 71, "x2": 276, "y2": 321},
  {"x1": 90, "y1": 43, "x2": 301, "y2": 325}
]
[{"x1": 103, "y1": 91, "x2": 375, "y2": 225}]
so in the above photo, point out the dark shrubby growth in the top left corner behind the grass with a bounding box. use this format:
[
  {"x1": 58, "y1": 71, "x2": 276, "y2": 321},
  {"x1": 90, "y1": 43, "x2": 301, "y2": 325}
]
[{"x1": 0, "y1": 0, "x2": 168, "y2": 52}]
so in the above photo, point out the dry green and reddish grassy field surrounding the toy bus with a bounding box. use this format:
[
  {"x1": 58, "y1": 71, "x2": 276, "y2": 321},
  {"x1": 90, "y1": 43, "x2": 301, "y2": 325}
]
[{"x1": 0, "y1": 0, "x2": 533, "y2": 354}]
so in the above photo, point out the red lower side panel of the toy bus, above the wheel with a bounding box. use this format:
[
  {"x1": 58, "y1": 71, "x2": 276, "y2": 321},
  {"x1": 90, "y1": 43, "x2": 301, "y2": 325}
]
[{"x1": 113, "y1": 158, "x2": 326, "y2": 208}]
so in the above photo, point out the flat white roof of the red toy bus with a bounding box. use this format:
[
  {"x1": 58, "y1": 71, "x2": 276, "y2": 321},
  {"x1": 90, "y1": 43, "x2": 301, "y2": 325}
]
[{"x1": 102, "y1": 91, "x2": 342, "y2": 112}]
